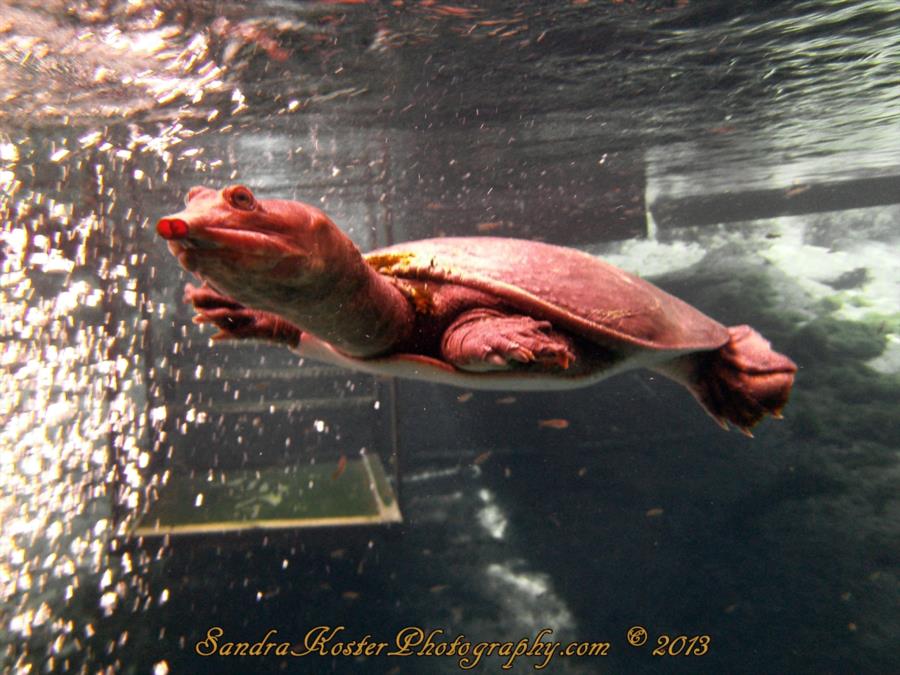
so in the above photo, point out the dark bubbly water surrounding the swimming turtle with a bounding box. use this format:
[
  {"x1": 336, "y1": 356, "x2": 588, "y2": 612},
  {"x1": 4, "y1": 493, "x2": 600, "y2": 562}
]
[{"x1": 0, "y1": 0, "x2": 900, "y2": 673}]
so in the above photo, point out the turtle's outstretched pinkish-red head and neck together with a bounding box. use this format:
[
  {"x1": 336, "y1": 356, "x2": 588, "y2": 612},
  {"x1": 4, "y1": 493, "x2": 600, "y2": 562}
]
[{"x1": 156, "y1": 185, "x2": 413, "y2": 357}]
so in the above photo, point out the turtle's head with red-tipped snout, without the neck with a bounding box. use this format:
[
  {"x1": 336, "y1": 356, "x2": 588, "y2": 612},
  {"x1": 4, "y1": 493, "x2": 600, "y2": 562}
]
[{"x1": 156, "y1": 185, "x2": 359, "y2": 303}]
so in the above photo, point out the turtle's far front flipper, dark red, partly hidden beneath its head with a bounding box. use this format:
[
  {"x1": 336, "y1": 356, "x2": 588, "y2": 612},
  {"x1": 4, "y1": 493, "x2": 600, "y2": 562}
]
[{"x1": 184, "y1": 284, "x2": 301, "y2": 347}]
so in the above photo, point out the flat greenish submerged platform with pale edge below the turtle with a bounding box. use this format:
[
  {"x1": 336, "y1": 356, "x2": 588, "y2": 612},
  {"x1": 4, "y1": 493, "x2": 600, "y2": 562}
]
[{"x1": 132, "y1": 453, "x2": 402, "y2": 537}]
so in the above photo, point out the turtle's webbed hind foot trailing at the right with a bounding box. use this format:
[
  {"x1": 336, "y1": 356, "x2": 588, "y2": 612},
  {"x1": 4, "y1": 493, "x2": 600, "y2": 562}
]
[{"x1": 665, "y1": 326, "x2": 797, "y2": 436}]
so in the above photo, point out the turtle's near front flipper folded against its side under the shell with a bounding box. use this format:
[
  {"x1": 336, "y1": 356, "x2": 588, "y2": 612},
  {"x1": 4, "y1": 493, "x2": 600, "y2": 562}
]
[{"x1": 441, "y1": 309, "x2": 575, "y2": 371}]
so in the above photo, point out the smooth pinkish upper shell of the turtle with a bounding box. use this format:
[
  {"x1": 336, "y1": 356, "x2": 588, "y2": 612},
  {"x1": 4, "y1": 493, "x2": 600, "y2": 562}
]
[{"x1": 366, "y1": 237, "x2": 729, "y2": 351}]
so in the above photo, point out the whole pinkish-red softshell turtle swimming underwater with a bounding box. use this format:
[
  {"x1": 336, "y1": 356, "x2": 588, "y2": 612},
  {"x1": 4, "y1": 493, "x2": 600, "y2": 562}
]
[{"x1": 157, "y1": 185, "x2": 797, "y2": 434}]
